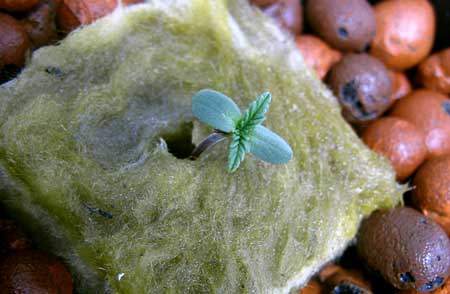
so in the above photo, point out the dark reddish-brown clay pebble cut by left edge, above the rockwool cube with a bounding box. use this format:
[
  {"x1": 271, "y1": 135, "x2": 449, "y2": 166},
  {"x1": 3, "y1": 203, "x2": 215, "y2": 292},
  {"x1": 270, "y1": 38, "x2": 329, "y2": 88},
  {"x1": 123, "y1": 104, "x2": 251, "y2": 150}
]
[{"x1": 0, "y1": 12, "x2": 31, "y2": 66}]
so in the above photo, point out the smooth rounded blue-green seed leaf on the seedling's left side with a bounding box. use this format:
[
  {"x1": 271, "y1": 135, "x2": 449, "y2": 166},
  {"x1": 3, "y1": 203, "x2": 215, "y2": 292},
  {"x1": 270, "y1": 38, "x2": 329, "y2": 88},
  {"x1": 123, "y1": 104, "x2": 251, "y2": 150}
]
[{"x1": 192, "y1": 89, "x2": 241, "y2": 133}]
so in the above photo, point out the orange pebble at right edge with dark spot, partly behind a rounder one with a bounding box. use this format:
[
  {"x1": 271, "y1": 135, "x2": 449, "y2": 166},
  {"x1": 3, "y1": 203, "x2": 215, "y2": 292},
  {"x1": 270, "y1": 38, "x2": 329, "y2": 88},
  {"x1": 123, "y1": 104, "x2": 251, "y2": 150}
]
[{"x1": 391, "y1": 90, "x2": 450, "y2": 157}]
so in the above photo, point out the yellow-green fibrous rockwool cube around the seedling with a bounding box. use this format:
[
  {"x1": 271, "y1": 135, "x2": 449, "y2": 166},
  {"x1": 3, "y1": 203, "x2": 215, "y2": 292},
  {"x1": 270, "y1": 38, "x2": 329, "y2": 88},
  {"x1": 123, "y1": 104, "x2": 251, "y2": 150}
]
[{"x1": 0, "y1": 0, "x2": 402, "y2": 293}]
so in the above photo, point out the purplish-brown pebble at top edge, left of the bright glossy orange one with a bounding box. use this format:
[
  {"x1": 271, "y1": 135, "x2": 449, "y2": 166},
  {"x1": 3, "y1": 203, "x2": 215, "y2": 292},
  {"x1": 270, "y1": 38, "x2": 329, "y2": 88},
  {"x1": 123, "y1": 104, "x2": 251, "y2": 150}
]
[{"x1": 305, "y1": 0, "x2": 376, "y2": 51}]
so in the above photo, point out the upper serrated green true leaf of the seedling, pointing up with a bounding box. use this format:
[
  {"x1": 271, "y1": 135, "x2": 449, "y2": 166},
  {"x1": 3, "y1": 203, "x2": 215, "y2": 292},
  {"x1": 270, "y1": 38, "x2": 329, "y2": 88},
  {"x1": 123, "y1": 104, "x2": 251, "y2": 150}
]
[{"x1": 238, "y1": 92, "x2": 272, "y2": 131}]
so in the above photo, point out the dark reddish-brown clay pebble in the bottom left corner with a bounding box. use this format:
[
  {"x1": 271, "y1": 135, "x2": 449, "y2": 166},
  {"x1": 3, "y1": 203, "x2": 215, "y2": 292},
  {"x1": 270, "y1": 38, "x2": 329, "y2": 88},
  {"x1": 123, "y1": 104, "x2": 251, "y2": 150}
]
[{"x1": 0, "y1": 250, "x2": 73, "y2": 294}]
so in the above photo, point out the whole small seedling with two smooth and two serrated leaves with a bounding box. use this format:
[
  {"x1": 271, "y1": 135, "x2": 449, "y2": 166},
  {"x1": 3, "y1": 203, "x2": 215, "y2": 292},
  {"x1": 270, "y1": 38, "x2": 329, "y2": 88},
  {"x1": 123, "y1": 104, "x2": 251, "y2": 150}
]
[{"x1": 191, "y1": 89, "x2": 292, "y2": 172}]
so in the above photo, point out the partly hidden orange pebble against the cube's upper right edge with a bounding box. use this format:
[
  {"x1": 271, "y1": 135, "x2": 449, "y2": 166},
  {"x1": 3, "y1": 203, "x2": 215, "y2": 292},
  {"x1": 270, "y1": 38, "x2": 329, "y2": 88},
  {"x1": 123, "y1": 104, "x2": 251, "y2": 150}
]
[{"x1": 295, "y1": 35, "x2": 342, "y2": 79}]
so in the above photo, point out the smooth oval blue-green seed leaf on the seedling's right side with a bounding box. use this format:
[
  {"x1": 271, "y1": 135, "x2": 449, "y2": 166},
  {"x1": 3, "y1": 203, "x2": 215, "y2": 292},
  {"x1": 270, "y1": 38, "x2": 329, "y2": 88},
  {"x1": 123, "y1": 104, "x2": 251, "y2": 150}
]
[{"x1": 249, "y1": 125, "x2": 293, "y2": 164}]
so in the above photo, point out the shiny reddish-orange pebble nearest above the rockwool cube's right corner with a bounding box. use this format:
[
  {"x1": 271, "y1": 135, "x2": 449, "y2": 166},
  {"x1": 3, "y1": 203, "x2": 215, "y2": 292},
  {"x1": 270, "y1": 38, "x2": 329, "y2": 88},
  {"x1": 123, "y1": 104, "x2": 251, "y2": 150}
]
[{"x1": 362, "y1": 117, "x2": 427, "y2": 181}]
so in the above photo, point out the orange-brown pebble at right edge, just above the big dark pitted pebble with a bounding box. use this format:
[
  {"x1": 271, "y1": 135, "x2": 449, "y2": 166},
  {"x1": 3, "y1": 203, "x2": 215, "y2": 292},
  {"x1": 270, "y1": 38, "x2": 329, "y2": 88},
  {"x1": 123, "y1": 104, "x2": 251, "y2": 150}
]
[{"x1": 412, "y1": 155, "x2": 450, "y2": 236}]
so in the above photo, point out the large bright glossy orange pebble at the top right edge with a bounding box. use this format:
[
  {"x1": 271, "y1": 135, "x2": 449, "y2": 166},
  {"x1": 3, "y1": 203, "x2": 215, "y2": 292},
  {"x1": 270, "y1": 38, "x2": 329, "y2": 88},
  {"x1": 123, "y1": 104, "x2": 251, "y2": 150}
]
[{"x1": 370, "y1": 0, "x2": 436, "y2": 70}]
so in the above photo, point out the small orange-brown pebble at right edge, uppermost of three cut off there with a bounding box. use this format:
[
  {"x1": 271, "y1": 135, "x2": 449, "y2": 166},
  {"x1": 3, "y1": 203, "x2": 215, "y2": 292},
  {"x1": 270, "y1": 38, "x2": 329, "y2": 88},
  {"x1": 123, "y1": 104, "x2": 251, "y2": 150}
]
[{"x1": 419, "y1": 48, "x2": 450, "y2": 94}]
